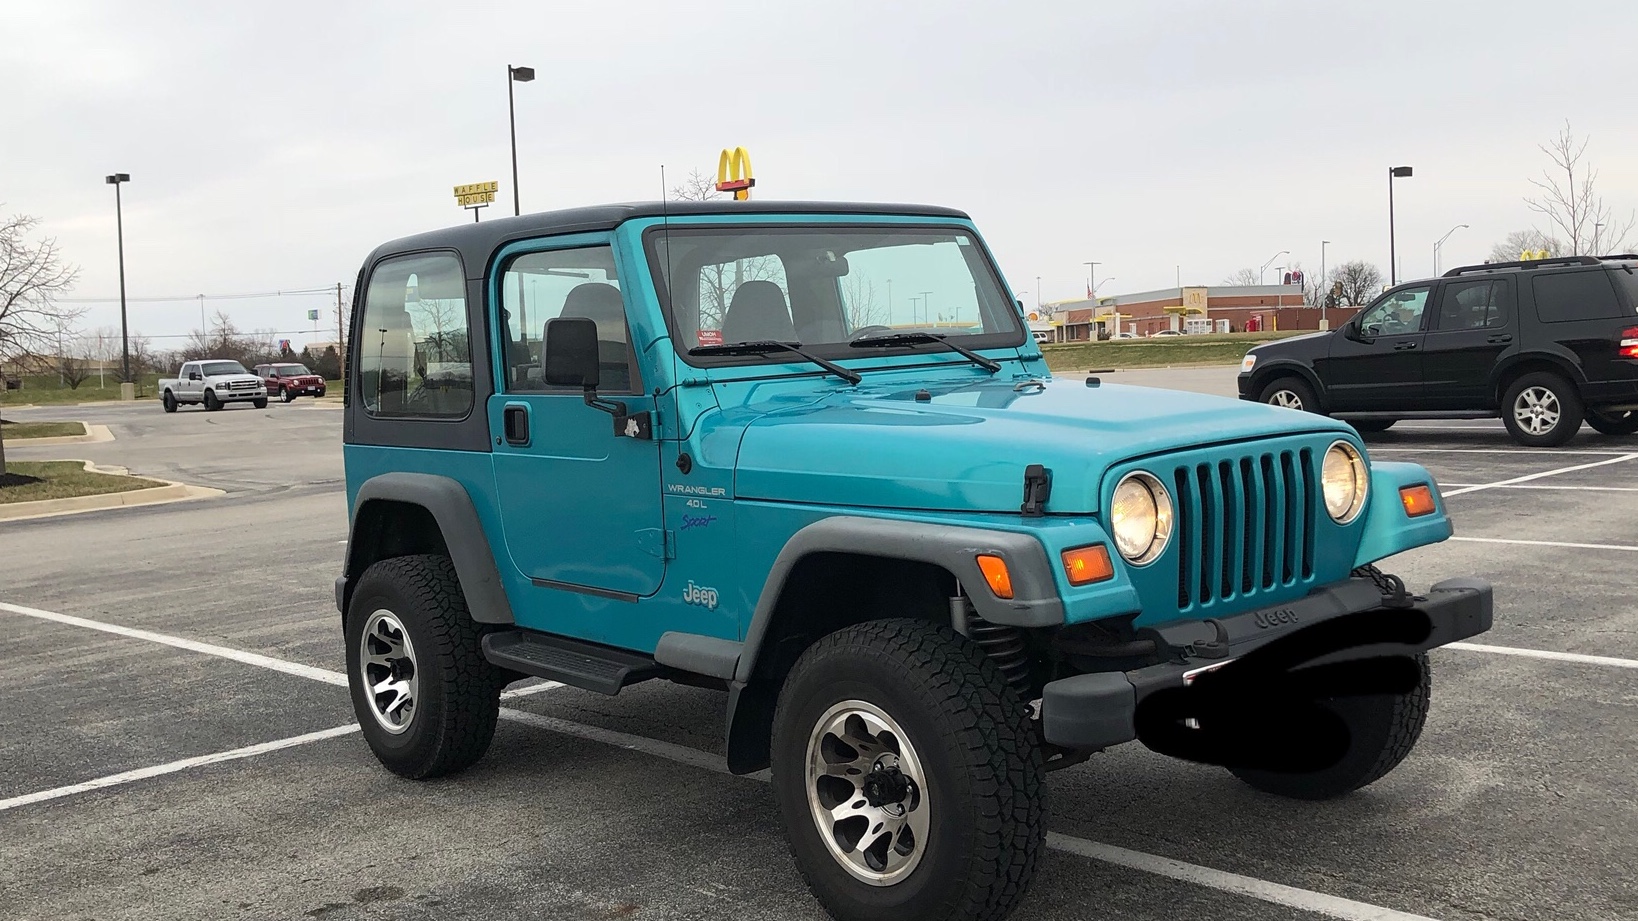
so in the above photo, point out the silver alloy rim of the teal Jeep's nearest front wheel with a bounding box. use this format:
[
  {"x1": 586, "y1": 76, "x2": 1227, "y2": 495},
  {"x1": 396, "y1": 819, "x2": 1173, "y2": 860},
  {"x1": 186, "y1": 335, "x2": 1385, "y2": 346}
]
[{"x1": 806, "y1": 700, "x2": 932, "y2": 887}]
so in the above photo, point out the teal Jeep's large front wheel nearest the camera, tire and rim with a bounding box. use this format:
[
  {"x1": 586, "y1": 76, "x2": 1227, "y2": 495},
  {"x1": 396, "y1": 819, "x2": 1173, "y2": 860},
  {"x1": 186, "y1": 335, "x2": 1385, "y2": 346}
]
[{"x1": 771, "y1": 619, "x2": 1047, "y2": 921}]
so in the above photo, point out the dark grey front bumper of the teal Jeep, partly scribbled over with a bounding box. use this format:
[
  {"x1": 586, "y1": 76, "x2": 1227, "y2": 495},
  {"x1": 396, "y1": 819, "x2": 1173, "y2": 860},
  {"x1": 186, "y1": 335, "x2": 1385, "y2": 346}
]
[{"x1": 1040, "y1": 578, "x2": 1492, "y2": 751}]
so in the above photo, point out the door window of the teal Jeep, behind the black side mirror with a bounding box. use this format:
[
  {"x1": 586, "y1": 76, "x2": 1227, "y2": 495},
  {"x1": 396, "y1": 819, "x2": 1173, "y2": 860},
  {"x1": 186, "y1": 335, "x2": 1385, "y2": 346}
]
[{"x1": 500, "y1": 246, "x2": 642, "y2": 393}]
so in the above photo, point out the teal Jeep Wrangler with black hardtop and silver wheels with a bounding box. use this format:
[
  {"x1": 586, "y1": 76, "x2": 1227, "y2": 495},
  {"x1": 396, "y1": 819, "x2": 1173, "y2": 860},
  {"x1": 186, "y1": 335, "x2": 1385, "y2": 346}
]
[{"x1": 336, "y1": 202, "x2": 1491, "y2": 919}]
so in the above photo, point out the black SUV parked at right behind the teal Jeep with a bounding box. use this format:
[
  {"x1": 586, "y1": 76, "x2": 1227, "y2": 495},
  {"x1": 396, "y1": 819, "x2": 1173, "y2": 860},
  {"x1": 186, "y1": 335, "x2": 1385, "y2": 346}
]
[{"x1": 1240, "y1": 254, "x2": 1638, "y2": 447}]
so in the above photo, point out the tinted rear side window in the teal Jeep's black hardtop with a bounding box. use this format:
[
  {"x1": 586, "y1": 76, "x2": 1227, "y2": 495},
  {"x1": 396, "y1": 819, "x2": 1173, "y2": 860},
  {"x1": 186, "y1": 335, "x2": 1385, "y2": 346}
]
[{"x1": 355, "y1": 252, "x2": 472, "y2": 418}]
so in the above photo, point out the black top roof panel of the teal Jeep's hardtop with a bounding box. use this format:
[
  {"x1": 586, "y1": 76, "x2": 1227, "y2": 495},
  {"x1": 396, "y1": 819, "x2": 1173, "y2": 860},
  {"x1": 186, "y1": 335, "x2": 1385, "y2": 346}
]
[{"x1": 369, "y1": 200, "x2": 968, "y2": 274}]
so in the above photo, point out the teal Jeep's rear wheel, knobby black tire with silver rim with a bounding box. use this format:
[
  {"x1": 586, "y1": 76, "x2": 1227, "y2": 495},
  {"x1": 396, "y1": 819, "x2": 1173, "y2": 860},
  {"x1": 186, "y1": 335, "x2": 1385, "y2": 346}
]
[{"x1": 344, "y1": 554, "x2": 509, "y2": 780}]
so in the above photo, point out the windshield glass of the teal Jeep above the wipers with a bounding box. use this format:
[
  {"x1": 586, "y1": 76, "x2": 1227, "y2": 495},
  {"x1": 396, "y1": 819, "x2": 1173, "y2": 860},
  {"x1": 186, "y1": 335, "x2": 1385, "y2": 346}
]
[{"x1": 645, "y1": 225, "x2": 1024, "y2": 362}]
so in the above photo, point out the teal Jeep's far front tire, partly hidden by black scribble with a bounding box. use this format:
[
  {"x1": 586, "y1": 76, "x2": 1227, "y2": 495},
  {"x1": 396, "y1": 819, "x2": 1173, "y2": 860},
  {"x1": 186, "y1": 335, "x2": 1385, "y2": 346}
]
[{"x1": 1230, "y1": 652, "x2": 1433, "y2": 800}]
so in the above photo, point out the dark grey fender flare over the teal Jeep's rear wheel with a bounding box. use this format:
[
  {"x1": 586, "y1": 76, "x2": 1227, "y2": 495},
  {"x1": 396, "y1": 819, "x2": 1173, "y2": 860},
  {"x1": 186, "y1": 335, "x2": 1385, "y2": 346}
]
[{"x1": 336, "y1": 474, "x2": 514, "y2": 624}]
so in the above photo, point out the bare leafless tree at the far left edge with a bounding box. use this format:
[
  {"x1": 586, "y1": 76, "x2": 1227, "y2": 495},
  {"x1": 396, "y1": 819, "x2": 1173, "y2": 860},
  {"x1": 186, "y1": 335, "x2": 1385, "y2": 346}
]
[{"x1": 0, "y1": 215, "x2": 85, "y2": 477}]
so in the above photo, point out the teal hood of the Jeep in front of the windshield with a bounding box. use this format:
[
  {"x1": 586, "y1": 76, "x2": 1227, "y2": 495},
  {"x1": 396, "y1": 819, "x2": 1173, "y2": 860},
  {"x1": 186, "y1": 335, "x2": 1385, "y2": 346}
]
[{"x1": 734, "y1": 380, "x2": 1350, "y2": 515}]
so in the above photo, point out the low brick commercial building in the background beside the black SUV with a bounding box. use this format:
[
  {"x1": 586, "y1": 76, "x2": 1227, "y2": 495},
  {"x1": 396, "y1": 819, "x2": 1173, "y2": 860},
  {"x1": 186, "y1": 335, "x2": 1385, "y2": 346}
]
[{"x1": 1050, "y1": 285, "x2": 1360, "y2": 343}]
